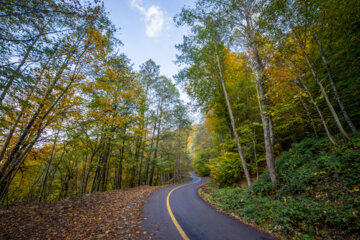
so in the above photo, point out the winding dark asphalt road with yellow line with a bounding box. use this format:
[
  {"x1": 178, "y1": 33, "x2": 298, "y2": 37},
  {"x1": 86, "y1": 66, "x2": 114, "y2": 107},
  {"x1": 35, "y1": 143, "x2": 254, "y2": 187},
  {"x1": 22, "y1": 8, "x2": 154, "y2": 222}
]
[{"x1": 143, "y1": 173, "x2": 274, "y2": 240}]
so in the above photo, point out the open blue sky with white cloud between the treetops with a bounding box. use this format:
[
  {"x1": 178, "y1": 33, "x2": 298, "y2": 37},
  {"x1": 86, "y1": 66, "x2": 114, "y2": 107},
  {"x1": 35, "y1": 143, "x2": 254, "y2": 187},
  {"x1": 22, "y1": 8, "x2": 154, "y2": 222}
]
[{"x1": 104, "y1": 0, "x2": 194, "y2": 78}]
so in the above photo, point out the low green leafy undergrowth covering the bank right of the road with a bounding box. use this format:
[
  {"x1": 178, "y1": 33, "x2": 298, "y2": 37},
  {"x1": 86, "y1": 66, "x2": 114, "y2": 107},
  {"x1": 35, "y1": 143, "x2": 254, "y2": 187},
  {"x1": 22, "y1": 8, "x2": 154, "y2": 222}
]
[{"x1": 208, "y1": 137, "x2": 360, "y2": 239}]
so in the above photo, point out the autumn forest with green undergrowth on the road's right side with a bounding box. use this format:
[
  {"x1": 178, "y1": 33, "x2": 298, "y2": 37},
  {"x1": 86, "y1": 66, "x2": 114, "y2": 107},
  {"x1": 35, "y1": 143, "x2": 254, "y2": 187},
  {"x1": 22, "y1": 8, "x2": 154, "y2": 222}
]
[{"x1": 178, "y1": 0, "x2": 360, "y2": 239}]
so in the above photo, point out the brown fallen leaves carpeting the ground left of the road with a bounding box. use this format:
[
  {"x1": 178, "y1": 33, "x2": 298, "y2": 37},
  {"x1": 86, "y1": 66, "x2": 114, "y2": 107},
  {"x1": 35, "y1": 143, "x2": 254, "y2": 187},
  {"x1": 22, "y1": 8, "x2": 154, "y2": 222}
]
[{"x1": 0, "y1": 186, "x2": 161, "y2": 240}]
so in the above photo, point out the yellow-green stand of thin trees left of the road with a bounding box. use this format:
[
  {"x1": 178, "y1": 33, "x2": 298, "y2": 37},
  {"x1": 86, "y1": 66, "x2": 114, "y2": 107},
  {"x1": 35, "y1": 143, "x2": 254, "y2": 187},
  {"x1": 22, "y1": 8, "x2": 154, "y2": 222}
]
[{"x1": 0, "y1": 0, "x2": 190, "y2": 204}]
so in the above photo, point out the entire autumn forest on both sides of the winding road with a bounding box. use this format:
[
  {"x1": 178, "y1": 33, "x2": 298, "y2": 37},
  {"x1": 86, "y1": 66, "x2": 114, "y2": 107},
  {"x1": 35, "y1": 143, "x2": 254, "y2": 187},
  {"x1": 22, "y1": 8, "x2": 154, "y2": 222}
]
[{"x1": 0, "y1": 0, "x2": 360, "y2": 239}]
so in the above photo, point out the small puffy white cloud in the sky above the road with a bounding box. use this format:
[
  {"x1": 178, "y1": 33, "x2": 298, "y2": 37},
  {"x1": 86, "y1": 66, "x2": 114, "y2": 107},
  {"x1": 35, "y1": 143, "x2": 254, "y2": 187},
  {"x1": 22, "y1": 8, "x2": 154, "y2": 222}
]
[{"x1": 129, "y1": 0, "x2": 164, "y2": 37}]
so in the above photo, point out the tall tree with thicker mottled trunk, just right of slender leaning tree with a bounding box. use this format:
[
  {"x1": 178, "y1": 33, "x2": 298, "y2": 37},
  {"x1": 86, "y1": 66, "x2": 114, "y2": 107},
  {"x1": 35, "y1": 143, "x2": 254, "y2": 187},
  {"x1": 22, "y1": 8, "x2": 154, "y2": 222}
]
[{"x1": 176, "y1": 0, "x2": 276, "y2": 188}]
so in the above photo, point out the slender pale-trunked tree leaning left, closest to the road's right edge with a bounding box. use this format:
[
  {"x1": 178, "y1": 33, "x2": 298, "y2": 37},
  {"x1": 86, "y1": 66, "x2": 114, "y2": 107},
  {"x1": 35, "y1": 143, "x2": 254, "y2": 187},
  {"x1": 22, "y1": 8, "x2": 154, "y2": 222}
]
[{"x1": 178, "y1": 12, "x2": 251, "y2": 186}]
